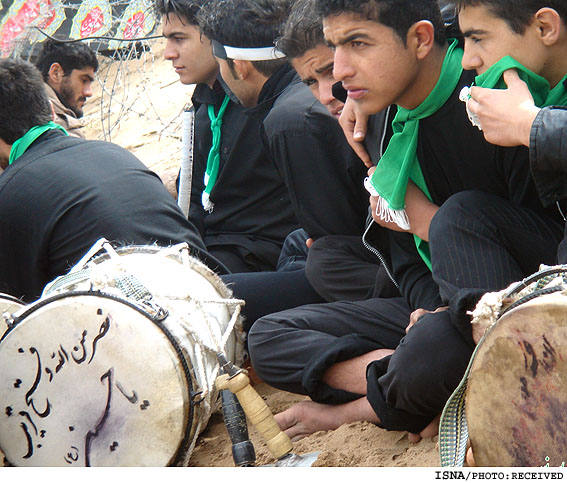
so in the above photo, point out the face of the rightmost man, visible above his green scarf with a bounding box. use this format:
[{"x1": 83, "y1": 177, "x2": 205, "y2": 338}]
[{"x1": 459, "y1": 5, "x2": 546, "y2": 74}]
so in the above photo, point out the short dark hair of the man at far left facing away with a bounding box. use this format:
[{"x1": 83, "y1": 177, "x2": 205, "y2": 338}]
[{"x1": 0, "y1": 59, "x2": 52, "y2": 144}]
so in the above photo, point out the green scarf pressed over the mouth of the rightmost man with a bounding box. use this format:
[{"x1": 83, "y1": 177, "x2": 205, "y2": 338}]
[{"x1": 475, "y1": 55, "x2": 567, "y2": 107}]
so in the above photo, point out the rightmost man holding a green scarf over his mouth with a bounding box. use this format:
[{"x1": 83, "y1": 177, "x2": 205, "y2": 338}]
[{"x1": 458, "y1": 0, "x2": 567, "y2": 263}]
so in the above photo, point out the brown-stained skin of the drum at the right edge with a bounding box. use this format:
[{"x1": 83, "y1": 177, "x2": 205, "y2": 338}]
[{"x1": 466, "y1": 293, "x2": 567, "y2": 467}]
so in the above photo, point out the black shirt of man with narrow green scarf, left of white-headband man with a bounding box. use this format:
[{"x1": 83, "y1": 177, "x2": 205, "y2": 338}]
[{"x1": 189, "y1": 81, "x2": 298, "y2": 269}]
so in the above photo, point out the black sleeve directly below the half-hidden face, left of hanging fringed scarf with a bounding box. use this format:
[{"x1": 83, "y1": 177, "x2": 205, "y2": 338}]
[{"x1": 264, "y1": 106, "x2": 368, "y2": 239}]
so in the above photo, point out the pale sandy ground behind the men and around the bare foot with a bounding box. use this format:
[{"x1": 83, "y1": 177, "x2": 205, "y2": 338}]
[{"x1": 76, "y1": 36, "x2": 439, "y2": 467}]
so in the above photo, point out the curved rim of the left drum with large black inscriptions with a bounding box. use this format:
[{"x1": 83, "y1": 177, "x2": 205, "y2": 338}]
[{"x1": 0, "y1": 290, "x2": 198, "y2": 466}]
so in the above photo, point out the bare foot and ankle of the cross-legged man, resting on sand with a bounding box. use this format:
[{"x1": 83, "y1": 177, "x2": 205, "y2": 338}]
[{"x1": 274, "y1": 397, "x2": 378, "y2": 441}]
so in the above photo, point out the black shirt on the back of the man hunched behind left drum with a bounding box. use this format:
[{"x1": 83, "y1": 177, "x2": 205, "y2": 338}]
[{"x1": 0, "y1": 131, "x2": 209, "y2": 302}]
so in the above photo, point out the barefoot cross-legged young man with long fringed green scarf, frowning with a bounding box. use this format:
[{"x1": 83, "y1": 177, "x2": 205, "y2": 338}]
[{"x1": 249, "y1": 0, "x2": 561, "y2": 440}]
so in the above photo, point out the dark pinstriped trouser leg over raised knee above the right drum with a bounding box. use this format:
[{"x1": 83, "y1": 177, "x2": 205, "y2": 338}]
[{"x1": 429, "y1": 191, "x2": 563, "y2": 302}]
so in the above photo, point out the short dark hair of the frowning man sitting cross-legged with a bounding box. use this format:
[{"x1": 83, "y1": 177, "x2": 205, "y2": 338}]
[{"x1": 316, "y1": 0, "x2": 446, "y2": 44}]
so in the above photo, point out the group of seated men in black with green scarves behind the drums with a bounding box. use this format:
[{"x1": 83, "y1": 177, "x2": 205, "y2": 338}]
[{"x1": 0, "y1": 0, "x2": 567, "y2": 454}]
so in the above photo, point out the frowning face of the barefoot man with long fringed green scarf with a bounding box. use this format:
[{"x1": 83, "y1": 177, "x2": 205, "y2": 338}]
[{"x1": 323, "y1": 13, "x2": 420, "y2": 114}]
